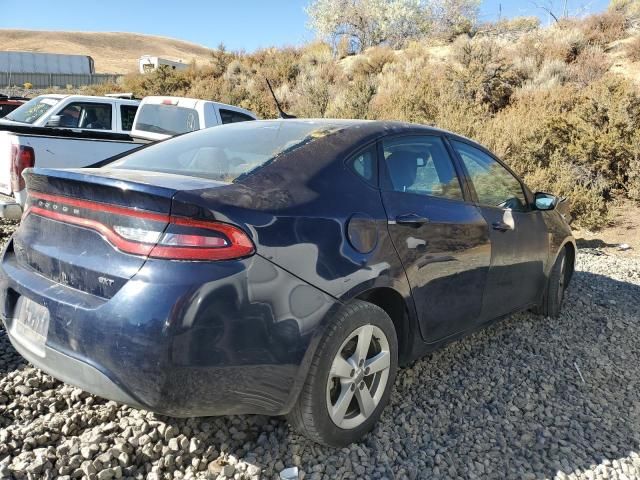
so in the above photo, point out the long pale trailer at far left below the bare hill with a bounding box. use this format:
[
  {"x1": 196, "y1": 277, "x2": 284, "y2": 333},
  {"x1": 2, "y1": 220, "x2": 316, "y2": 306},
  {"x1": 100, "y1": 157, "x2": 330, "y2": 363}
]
[{"x1": 0, "y1": 52, "x2": 95, "y2": 75}]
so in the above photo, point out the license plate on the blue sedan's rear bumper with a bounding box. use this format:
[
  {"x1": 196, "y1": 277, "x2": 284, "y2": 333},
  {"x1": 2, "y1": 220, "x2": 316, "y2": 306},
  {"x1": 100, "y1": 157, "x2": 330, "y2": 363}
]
[{"x1": 12, "y1": 297, "x2": 49, "y2": 357}]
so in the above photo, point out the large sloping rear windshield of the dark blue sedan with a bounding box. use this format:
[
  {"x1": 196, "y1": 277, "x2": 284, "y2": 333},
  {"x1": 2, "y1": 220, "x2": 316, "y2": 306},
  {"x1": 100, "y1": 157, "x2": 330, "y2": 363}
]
[{"x1": 111, "y1": 120, "x2": 344, "y2": 182}]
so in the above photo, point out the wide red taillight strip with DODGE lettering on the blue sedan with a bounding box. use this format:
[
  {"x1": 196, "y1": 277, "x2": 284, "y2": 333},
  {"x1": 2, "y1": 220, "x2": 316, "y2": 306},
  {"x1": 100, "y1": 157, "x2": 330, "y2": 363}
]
[{"x1": 25, "y1": 192, "x2": 255, "y2": 260}]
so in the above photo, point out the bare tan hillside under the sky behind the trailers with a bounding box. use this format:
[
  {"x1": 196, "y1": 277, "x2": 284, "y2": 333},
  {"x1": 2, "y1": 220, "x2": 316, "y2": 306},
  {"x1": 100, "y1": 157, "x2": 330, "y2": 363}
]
[{"x1": 0, "y1": 29, "x2": 216, "y2": 73}]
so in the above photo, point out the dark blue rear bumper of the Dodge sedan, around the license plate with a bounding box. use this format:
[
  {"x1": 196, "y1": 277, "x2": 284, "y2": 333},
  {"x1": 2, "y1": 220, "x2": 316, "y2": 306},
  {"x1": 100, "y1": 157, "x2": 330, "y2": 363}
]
[{"x1": 0, "y1": 244, "x2": 338, "y2": 417}]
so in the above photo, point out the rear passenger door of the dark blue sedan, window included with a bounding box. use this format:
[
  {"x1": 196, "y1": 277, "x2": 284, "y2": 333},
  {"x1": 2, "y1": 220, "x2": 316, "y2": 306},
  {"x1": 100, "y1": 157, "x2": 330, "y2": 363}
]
[{"x1": 380, "y1": 135, "x2": 491, "y2": 343}]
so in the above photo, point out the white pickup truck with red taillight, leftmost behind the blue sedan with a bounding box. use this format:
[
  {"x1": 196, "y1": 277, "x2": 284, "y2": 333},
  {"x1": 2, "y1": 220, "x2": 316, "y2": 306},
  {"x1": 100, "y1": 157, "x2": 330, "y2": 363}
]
[{"x1": 0, "y1": 95, "x2": 148, "y2": 219}]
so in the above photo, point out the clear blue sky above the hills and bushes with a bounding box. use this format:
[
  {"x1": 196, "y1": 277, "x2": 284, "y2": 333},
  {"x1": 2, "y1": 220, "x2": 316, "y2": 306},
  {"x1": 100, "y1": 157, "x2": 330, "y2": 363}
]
[{"x1": 0, "y1": 0, "x2": 608, "y2": 51}]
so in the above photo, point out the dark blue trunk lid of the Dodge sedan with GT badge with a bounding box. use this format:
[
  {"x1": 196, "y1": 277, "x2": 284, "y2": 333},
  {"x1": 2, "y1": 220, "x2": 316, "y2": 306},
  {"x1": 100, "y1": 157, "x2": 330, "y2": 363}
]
[{"x1": 13, "y1": 169, "x2": 224, "y2": 298}]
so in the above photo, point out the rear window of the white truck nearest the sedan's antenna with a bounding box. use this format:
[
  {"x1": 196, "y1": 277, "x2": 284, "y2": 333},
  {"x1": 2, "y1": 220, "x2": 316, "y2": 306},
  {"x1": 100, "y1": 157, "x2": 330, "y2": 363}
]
[{"x1": 135, "y1": 103, "x2": 200, "y2": 135}]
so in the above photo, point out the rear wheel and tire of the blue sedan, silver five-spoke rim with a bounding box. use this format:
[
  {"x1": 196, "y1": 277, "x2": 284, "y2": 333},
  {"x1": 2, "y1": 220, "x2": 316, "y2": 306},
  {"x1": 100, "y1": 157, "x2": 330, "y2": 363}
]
[{"x1": 287, "y1": 300, "x2": 398, "y2": 447}]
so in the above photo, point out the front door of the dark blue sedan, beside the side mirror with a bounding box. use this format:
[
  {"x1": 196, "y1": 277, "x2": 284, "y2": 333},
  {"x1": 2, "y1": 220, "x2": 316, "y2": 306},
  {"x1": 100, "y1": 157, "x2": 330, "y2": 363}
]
[{"x1": 451, "y1": 140, "x2": 548, "y2": 322}]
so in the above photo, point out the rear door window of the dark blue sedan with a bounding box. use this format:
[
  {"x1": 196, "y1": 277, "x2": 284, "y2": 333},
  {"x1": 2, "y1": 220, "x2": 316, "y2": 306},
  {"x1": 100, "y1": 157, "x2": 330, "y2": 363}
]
[{"x1": 383, "y1": 136, "x2": 463, "y2": 200}]
